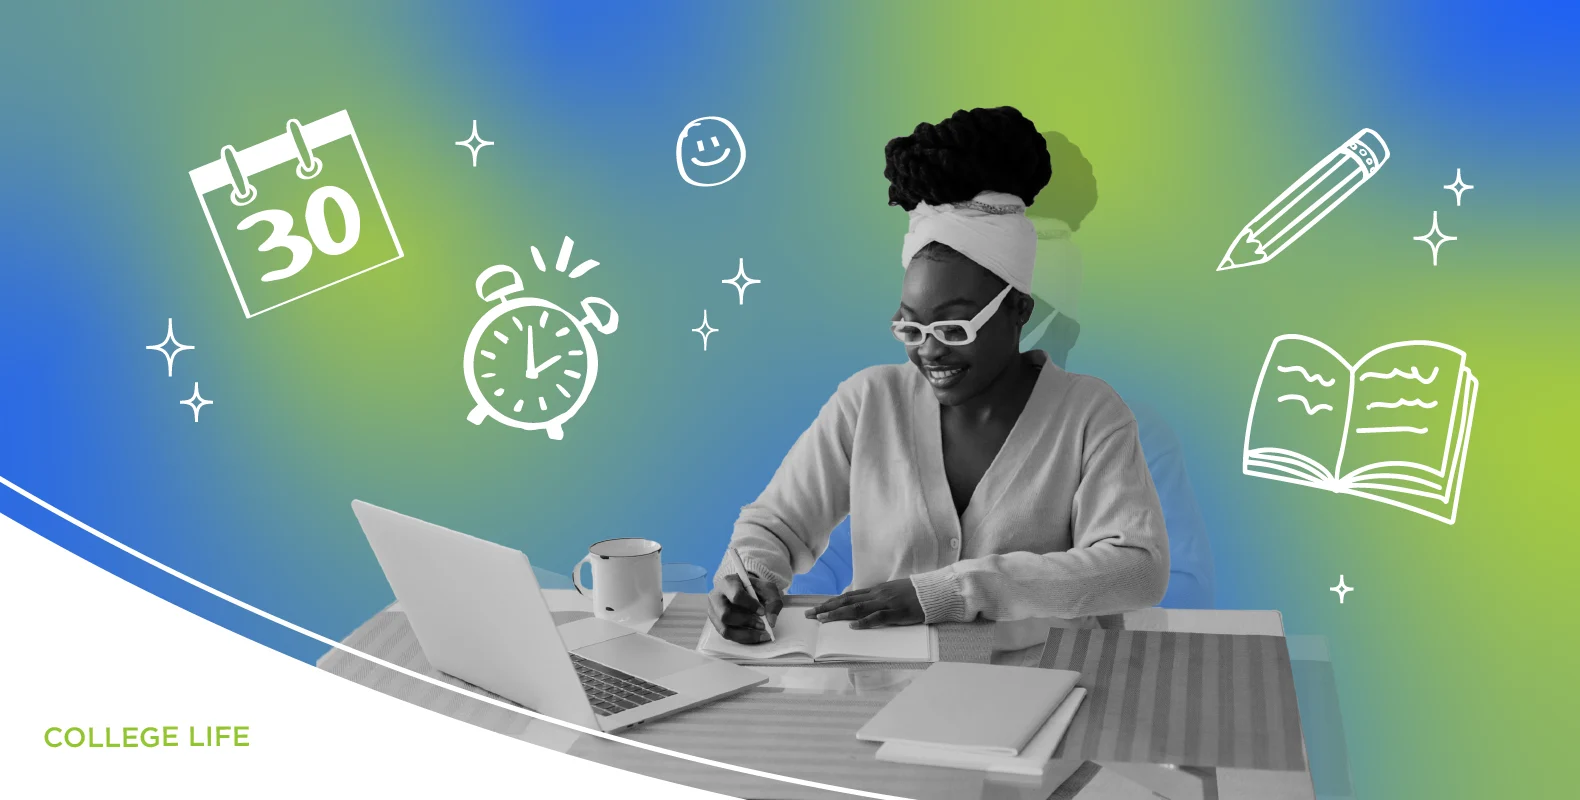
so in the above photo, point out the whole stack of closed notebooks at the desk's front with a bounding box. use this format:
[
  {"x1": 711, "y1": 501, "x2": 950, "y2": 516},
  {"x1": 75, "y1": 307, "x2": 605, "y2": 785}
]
[{"x1": 856, "y1": 662, "x2": 1085, "y2": 775}]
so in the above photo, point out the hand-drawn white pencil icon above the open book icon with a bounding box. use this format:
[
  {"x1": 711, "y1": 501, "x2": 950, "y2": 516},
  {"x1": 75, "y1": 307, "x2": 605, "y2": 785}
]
[{"x1": 1218, "y1": 128, "x2": 1387, "y2": 272}]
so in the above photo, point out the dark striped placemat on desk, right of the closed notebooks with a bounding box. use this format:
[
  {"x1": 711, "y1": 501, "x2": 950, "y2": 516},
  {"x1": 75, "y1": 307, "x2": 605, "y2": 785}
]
[{"x1": 1041, "y1": 628, "x2": 1305, "y2": 770}]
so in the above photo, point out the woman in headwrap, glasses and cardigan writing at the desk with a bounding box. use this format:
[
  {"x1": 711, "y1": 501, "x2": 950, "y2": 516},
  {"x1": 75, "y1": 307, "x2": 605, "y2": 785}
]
[{"x1": 709, "y1": 108, "x2": 1169, "y2": 643}]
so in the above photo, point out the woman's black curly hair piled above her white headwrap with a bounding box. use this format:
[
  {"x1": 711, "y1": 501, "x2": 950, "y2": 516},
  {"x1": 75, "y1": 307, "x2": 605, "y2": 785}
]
[{"x1": 883, "y1": 106, "x2": 1052, "y2": 212}]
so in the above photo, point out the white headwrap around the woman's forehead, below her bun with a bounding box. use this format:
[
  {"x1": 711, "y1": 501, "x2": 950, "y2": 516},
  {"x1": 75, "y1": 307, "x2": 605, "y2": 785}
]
[{"x1": 899, "y1": 191, "x2": 1036, "y2": 294}]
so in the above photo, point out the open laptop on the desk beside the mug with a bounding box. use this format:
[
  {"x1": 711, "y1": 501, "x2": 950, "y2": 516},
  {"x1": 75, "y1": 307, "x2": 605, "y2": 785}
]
[{"x1": 351, "y1": 500, "x2": 768, "y2": 732}]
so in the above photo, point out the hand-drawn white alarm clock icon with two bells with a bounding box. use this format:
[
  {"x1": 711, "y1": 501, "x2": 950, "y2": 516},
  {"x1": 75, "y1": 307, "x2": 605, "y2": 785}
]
[{"x1": 463, "y1": 264, "x2": 619, "y2": 440}]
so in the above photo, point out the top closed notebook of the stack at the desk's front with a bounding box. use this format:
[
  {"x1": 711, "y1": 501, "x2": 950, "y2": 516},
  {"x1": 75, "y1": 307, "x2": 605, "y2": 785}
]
[{"x1": 856, "y1": 662, "x2": 1081, "y2": 756}]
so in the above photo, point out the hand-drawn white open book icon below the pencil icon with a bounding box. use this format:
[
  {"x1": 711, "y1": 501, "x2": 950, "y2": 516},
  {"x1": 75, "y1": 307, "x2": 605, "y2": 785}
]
[{"x1": 1243, "y1": 334, "x2": 1477, "y2": 525}]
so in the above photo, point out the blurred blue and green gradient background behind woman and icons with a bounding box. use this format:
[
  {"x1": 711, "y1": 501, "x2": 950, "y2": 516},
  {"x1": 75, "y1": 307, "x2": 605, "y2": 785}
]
[{"x1": 0, "y1": 3, "x2": 1580, "y2": 798}]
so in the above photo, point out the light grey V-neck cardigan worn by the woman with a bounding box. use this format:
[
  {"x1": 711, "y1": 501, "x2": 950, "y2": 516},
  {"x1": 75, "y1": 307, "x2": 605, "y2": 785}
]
[{"x1": 720, "y1": 351, "x2": 1169, "y2": 623}]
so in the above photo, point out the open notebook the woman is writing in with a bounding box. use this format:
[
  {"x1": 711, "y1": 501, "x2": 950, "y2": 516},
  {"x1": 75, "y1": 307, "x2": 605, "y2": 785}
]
[{"x1": 697, "y1": 607, "x2": 939, "y2": 664}]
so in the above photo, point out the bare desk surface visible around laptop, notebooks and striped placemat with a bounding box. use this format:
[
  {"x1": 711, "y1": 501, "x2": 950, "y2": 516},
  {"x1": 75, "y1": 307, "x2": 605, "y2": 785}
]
[{"x1": 319, "y1": 590, "x2": 1315, "y2": 800}]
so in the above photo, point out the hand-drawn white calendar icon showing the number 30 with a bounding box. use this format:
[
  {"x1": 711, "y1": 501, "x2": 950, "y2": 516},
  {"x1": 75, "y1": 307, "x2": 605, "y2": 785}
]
[{"x1": 191, "y1": 111, "x2": 404, "y2": 318}]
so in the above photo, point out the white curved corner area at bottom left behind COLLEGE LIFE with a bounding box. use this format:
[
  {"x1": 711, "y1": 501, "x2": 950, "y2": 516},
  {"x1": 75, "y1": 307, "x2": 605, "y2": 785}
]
[{"x1": 0, "y1": 509, "x2": 717, "y2": 800}]
